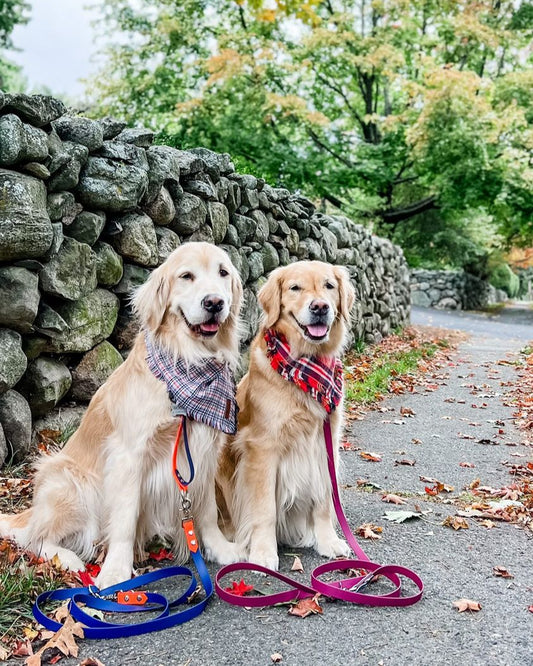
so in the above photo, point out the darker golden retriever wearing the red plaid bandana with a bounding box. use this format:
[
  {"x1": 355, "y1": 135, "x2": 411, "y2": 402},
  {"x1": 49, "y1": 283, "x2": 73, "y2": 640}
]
[{"x1": 218, "y1": 261, "x2": 354, "y2": 569}]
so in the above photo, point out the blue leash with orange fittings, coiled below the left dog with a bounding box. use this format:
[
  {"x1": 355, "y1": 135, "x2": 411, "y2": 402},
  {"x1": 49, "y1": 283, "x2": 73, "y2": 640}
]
[{"x1": 33, "y1": 414, "x2": 213, "y2": 638}]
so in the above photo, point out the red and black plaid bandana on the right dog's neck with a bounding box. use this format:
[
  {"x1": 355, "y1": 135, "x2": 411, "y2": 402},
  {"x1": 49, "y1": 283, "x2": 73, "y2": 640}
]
[{"x1": 265, "y1": 329, "x2": 343, "y2": 414}]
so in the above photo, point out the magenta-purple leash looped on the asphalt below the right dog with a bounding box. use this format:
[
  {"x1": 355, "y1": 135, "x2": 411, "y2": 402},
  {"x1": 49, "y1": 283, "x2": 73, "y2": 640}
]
[{"x1": 215, "y1": 419, "x2": 424, "y2": 607}]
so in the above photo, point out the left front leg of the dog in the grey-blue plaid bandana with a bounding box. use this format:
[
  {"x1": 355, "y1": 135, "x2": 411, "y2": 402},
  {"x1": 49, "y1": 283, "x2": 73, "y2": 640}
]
[{"x1": 97, "y1": 441, "x2": 142, "y2": 589}]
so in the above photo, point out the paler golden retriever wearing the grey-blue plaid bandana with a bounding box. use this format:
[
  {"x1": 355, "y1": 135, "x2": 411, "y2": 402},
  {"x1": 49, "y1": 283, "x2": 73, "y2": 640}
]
[{"x1": 0, "y1": 243, "x2": 242, "y2": 588}]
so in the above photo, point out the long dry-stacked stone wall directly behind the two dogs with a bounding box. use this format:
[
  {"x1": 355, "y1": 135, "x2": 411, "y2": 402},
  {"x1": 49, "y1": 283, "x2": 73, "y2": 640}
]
[{"x1": 0, "y1": 95, "x2": 409, "y2": 464}]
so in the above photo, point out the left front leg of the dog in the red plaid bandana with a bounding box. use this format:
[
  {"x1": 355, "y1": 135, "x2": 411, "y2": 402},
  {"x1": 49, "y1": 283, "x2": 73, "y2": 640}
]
[{"x1": 236, "y1": 443, "x2": 279, "y2": 571}]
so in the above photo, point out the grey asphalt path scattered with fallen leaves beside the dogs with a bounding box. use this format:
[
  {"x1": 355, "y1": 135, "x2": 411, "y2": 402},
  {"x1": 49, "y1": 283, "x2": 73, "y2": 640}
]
[{"x1": 23, "y1": 309, "x2": 533, "y2": 666}]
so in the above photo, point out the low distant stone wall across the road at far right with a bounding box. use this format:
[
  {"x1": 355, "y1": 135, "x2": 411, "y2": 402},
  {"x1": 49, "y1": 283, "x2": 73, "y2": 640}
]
[{"x1": 411, "y1": 269, "x2": 508, "y2": 310}]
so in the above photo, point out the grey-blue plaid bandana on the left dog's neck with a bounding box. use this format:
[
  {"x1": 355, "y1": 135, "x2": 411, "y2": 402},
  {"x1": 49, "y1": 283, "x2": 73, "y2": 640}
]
[{"x1": 145, "y1": 335, "x2": 237, "y2": 435}]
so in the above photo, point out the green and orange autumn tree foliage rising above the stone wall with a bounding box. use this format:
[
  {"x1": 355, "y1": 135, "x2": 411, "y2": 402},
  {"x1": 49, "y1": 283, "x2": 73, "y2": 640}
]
[{"x1": 89, "y1": 0, "x2": 533, "y2": 263}]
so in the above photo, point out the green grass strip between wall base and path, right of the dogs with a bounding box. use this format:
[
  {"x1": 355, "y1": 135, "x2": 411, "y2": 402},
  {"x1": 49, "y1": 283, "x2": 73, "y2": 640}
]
[{"x1": 346, "y1": 343, "x2": 437, "y2": 405}]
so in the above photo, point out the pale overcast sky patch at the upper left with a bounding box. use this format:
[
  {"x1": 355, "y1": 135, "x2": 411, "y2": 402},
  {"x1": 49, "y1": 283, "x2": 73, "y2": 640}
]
[{"x1": 9, "y1": 0, "x2": 98, "y2": 99}]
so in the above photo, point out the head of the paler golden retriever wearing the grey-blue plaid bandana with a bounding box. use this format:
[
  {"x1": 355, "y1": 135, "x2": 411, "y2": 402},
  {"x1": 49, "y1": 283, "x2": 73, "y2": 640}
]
[{"x1": 133, "y1": 243, "x2": 242, "y2": 342}]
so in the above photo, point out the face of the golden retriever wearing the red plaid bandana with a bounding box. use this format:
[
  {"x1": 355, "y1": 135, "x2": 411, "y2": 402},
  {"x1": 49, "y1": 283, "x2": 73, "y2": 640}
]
[{"x1": 258, "y1": 261, "x2": 354, "y2": 355}]
